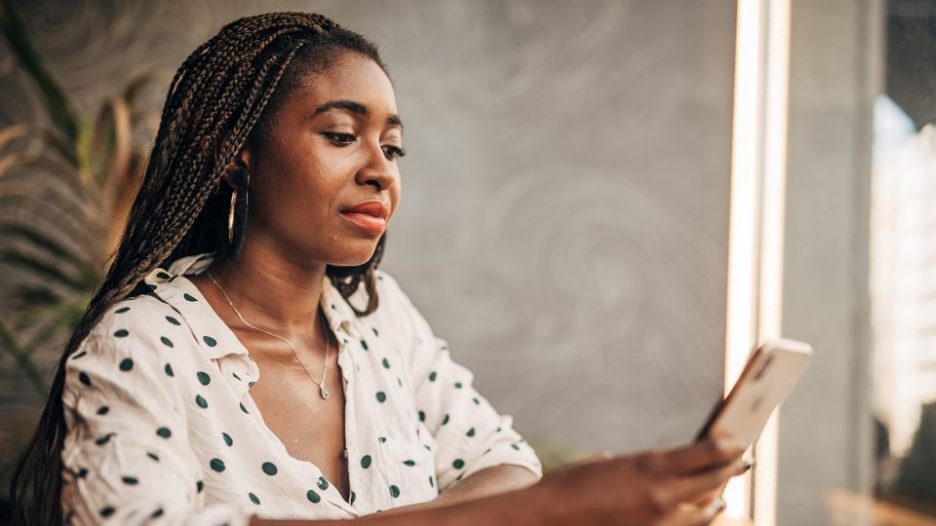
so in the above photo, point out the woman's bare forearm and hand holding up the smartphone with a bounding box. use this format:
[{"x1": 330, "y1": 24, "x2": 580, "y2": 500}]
[{"x1": 250, "y1": 441, "x2": 751, "y2": 526}]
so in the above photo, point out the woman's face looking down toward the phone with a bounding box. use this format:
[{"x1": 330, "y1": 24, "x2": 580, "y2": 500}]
[{"x1": 243, "y1": 52, "x2": 403, "y2": 266}]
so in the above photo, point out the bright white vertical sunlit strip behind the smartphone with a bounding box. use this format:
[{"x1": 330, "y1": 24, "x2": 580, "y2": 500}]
[{"x1": 724, "y1": 0, "x2": 790, "y2": 526}]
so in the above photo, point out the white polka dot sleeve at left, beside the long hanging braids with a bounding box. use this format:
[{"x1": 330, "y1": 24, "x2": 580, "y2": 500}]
[{"x1": 61, "y1": 302, "x2": 251, "y2": 526}]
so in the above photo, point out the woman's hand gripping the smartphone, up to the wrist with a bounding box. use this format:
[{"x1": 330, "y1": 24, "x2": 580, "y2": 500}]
[{"x1": 537, "y1": 440, "x2": 750, "y2": 526}]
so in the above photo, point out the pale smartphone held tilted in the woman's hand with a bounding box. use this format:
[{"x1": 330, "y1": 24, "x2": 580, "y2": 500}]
[{"x1": 696, "y1": 338, "x2": 812, "y2": 445}]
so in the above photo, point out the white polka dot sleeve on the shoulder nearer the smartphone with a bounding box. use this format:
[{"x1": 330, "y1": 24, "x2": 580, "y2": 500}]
[{"x1": 381, "y1": 275, "x2": 543, "y2": 491}]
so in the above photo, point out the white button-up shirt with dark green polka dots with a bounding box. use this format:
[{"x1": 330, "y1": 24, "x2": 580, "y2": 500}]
[{"x1": 62, "y1": 253, "x2": 542, "y2": 526}]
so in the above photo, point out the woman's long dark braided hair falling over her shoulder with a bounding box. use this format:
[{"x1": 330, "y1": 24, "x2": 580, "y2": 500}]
[{"x1": 10, "y1": 13, "x2": 389, "y2": 526}]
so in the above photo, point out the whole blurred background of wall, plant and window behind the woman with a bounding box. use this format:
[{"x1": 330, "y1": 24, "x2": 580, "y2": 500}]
[{"x1": 0, "y1": 0, "x2": 936, "y2": 525}]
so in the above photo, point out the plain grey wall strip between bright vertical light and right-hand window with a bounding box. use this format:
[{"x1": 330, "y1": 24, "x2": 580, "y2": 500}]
[{"x1": 777, "y1": 0, "x2": 883, "y2": 526}]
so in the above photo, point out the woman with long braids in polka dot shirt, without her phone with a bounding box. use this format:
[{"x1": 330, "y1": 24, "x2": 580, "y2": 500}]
[{"x1": 11, "y1": 13, "x2": 749, "y2": 525}]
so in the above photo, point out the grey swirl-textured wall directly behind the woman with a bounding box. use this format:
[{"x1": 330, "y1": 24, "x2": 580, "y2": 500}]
[{"x1": 0, "y1": 0, "x2": 735, "y2": 460}]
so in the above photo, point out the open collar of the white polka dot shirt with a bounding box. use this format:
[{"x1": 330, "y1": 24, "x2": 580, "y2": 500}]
[{"x1": 144, "y1": 252, "x2": 357, "y2": 360}]
